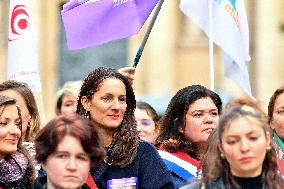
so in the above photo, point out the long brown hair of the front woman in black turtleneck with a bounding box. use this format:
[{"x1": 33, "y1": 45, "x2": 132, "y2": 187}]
[{"x1": 201, "y1": 105, "x2": 284, "y2": 189}]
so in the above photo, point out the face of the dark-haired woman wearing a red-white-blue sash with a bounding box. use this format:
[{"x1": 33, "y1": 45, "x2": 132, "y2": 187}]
[{"x1": 181, "y1": 97, "x2": 219, "y2": 147}]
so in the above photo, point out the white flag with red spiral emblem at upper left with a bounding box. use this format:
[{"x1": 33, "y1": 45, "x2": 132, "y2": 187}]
[{"x1": 7, "y1": 0, "x2": 41, "y2": 92}]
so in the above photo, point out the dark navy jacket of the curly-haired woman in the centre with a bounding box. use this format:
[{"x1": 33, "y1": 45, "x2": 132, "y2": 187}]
[{"x1": 91, "y1": 141, "x2": 174, "y2": 189}]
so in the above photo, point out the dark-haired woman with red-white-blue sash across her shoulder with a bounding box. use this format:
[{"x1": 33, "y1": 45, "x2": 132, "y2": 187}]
[{"x1": 157, "y1": 85, "x2": 222, "y2": 188}]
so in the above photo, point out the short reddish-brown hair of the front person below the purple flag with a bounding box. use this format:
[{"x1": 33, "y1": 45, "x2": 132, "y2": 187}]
[{"x1": 35, "y1": 115, "x2": 105, "y2": 166}]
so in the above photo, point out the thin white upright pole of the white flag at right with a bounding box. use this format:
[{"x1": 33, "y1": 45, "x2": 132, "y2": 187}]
[{"x1": 208, "y1": 0, "x2": 215, "y2": 91}]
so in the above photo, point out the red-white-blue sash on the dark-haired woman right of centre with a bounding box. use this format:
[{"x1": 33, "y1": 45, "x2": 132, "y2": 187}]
[{"x1": 158, "y1": 150, "x2": 200, "y2": 180}]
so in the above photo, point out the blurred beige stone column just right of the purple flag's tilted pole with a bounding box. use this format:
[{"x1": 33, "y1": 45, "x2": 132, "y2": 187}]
[{"x1": 130, "y1": 1, "x2": 179, "y2": 96}]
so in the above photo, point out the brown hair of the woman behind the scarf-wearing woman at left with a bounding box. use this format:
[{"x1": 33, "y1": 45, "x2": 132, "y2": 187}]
[{"x1": 0, "y1": 80, "x2": 40, "y2": 141}]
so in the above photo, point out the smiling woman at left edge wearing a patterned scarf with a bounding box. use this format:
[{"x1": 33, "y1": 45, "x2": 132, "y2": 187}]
[{"x1": 0, "y1": 96, "x2": 35, "y2": 189}]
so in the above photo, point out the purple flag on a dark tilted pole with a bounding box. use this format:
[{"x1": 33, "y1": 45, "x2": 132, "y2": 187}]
[{"x1": 61, "y1": 0, "x2": 158, "y2": 50}]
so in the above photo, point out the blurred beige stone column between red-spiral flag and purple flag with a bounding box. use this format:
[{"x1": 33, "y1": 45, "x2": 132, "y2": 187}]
[{"x1": 36, "y1": 0, "x2": 61, "y2": 121}]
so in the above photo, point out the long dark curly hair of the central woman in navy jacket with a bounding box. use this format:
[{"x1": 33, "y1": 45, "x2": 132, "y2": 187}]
[{"x1": 77, "y1": 67, "x2": 139, "y2": 167}]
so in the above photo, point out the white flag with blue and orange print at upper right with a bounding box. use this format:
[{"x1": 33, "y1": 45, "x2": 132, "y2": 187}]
[{"x1": 180, "y1": 0, "x2": 252, "y2": 96}]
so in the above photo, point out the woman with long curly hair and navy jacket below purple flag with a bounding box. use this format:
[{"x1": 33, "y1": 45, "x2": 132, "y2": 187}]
[{"x1": 77, "y1": 68, "x2": 173, "y2": 189}]
